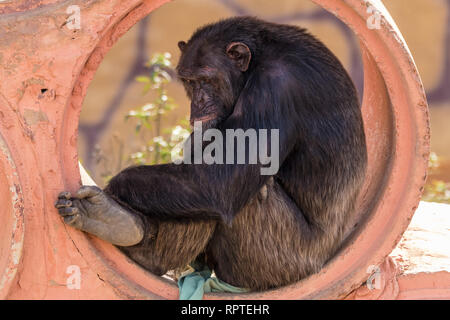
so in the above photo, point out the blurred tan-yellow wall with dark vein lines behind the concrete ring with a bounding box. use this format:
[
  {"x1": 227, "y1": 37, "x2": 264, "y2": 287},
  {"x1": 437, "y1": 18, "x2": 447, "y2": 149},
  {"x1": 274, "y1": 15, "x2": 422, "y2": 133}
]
[{"x1": 79, "y1": 0, "x2": 450, "y2": 183}]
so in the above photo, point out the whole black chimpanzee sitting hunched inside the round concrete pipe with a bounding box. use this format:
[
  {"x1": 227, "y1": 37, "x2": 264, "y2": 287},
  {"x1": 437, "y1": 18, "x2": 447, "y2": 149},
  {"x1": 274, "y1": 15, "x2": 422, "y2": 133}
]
[{"x1": 56, "y1": 17, "x2": 367, "y2": 290}]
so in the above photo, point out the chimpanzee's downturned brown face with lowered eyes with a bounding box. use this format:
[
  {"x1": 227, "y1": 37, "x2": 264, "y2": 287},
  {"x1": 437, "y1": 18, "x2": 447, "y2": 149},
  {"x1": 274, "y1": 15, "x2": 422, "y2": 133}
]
[{"x1": 177, "y1": 42, "x2": 253, "y2": 127}]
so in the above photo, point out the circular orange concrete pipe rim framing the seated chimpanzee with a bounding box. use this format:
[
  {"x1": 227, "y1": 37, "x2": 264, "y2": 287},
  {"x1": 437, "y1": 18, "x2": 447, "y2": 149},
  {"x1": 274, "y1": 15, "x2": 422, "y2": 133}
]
[{"x1": 60, "y1": 0, "x2": 429, "y2": 299}]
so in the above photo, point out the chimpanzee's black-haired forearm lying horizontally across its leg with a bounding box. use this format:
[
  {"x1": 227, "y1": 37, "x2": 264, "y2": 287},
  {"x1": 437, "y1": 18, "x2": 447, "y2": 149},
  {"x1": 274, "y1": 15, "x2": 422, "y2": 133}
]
[{"x1": 105, "y1": 164, "x2": 267, "y2": 221}]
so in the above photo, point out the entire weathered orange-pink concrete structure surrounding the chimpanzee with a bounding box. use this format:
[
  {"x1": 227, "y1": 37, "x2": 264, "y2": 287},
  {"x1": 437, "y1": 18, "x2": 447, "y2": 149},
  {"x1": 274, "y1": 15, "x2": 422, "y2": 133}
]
[{"x1": 0, "y1": 0, "x2": 444, "y2": 299}]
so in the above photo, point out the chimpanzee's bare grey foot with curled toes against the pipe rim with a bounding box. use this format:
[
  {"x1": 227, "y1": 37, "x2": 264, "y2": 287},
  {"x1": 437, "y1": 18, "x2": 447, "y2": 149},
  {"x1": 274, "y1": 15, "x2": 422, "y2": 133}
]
[{"x1": 55, "y1": 186, "x2": 144, "y2": 246}]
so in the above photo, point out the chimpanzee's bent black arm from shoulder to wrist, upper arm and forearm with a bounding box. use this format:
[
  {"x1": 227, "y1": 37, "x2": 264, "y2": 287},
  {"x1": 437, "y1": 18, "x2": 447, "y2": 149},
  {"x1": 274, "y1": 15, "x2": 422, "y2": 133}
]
[{"x1": 105, "y1": 70, "x2": 297, "y2": 221}]
